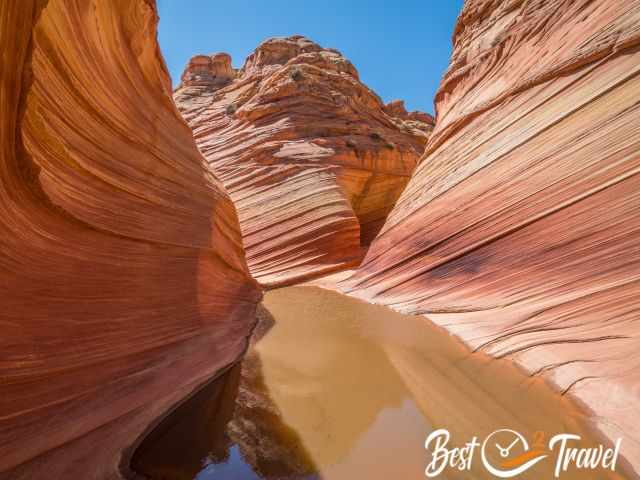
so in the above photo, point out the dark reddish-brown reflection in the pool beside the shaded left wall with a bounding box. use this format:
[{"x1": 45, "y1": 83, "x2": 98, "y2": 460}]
[{"x1": 131, "y1": 306, "x2": 316, "y2": 480}]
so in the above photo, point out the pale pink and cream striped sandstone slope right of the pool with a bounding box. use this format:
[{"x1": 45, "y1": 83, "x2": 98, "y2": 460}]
[{"x1": 347, "y1": 0, "x2": 640, "y2": 471}]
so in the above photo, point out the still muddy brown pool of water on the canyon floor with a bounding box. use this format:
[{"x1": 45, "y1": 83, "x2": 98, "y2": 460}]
[{"x1": 132, "y1": 287, "x2": 626, "y2": 480}]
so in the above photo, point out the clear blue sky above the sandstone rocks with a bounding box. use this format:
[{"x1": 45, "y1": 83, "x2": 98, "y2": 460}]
[{"x1": 157, "y1": 0, "x2": 463, "y2": 113}]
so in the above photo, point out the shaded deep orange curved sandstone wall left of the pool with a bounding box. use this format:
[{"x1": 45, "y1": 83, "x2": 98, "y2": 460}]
[{"x1": 0, "y1": 0, "x2": 259, "y2": 479}]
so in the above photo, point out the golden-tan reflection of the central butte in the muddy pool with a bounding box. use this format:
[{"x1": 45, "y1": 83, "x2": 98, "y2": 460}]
[{"x1": 254, "y1": 287, "x2": 410, "y2": 468}]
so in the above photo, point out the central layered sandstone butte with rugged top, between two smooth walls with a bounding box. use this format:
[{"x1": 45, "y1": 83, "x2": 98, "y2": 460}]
[{"x1": 174, "y1": 36, "x2": 433, "y2": 285}]
